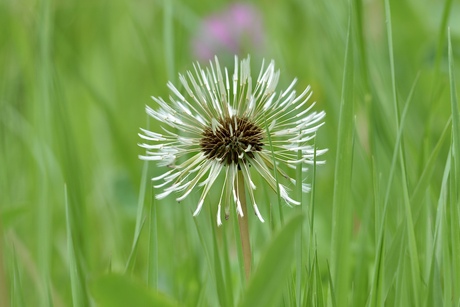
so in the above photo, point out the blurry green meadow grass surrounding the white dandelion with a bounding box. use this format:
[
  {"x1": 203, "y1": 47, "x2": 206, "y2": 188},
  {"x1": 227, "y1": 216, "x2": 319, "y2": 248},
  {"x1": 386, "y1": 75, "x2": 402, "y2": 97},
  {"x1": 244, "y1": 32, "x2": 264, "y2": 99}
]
[{"x1": 0, "y1": 0, "x2": 460, "y2": 306}]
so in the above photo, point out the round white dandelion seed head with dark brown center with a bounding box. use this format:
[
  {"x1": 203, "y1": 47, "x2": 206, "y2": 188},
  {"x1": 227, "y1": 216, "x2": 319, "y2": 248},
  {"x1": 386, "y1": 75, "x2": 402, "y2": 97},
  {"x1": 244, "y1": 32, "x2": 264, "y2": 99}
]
[{"x1": 139, "y1": 57, "x2": 326, "y2": 225}]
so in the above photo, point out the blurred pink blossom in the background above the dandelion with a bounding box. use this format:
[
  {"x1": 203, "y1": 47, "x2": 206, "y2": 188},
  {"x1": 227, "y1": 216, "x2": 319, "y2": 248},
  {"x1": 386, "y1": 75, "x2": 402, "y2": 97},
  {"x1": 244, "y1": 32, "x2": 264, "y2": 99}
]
[{"x1": 192, "y1": 3, "x2": 264, "y2": 60}]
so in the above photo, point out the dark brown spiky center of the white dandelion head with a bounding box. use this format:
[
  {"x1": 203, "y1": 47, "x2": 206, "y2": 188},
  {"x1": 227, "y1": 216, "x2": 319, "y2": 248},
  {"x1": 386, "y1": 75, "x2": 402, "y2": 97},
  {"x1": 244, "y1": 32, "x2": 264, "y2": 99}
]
[{"x1": 200, "y1": 116, "x2": 264, "y2": 166}]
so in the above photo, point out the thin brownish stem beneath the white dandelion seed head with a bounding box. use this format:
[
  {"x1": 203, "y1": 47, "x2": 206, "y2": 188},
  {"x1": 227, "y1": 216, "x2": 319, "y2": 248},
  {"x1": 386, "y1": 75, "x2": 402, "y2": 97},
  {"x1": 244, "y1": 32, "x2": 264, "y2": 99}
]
[{"x1": 238, "y1": 171, "x2": 252, "y2": 280}]
